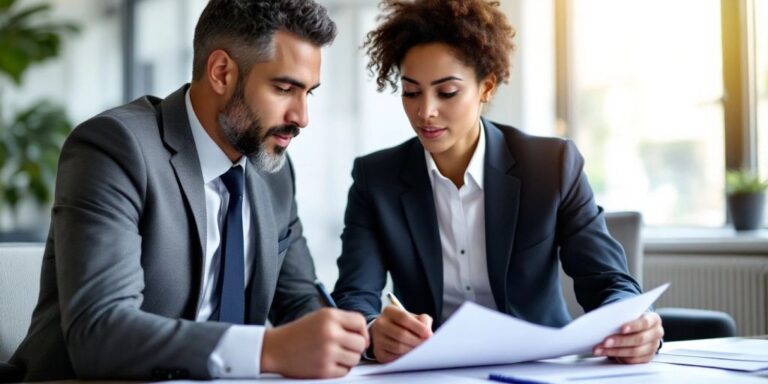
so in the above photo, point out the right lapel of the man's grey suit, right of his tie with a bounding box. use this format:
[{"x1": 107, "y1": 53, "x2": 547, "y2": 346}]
[{"x1": 246, "y1": 167, "x2": 279, "y2": 324}]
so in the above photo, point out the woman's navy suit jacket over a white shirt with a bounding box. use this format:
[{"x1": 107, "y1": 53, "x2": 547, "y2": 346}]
[{"x1": 333, "y1": 119, "x2": 641, "y2": 328}]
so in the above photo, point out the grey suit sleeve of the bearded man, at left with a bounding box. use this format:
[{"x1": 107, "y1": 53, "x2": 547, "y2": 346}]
[{"x1": 52, "y1": 116, "x2": 227, "y2": 379}]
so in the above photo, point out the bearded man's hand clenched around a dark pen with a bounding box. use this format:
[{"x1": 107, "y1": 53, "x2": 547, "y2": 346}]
[{"x1": 261, "y1": 308, "x2": 369, "y2": 379}]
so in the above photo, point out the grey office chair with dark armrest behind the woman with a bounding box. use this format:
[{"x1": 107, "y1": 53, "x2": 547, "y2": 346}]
[{"x1": 560, "y1": 212, "x2": 736, "y2": 341}]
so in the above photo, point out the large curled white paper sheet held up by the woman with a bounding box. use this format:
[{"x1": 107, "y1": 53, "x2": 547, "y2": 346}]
[{"x1": 352, "y1": 283, "x2": 669, "y2": 375}]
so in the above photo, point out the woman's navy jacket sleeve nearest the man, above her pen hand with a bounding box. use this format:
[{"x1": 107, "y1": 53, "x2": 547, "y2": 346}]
[{"x1": 333, "y1": 159, "x2": 387, "y2": 321}]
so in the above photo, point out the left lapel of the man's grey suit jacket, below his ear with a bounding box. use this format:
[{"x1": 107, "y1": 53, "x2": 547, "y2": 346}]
[{"x1": 161, "y1": 85, "x2": 206, "y2": 314}]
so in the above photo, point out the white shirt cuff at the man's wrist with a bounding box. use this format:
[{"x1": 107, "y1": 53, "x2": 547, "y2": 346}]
[{"x1": 208, "y1": 325, "x2": 265, "y2": 379}]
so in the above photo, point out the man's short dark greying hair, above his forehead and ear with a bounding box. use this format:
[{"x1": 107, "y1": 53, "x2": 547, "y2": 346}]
[{"x1": 192, "y1": 0, "x2": 336, "y2": 79}]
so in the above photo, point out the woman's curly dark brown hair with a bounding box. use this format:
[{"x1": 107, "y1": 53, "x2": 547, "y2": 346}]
[{"x1": 363, "y1": 0, "x2": 515, "y2": 92}]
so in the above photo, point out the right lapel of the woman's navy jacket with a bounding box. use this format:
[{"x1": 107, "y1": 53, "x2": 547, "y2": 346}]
[{"x1": 483, "y1": 119, "x2": 520, "y2": 313}]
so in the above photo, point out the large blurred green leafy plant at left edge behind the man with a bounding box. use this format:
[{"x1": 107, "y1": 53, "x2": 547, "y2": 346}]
[{"x1": 0, "y1": 0, "x2": 78, "y2": 241}]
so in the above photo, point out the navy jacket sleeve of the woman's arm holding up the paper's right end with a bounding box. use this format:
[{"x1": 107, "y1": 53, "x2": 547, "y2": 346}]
[{"x1": 557, "y1": 141, "x2": 641, "y2": 311}]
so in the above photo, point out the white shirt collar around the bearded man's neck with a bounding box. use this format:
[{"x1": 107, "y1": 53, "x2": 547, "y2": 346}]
[{"x1": 184, "y1": 89, "x2": 247, "y2": 184}]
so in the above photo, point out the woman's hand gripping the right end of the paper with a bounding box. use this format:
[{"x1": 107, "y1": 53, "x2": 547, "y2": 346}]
[{"x1": 592, "y1": 312, "x2": 664, "y2": 364}]
